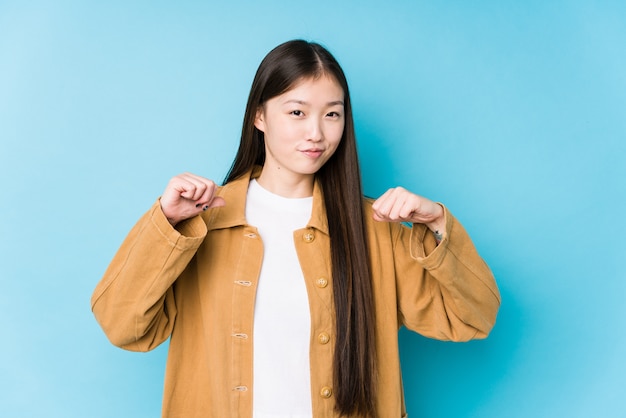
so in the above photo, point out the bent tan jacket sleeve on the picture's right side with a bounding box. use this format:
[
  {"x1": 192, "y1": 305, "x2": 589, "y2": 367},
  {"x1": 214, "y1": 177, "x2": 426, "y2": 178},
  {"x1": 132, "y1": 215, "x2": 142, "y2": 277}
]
[{"x1": 394, "y1": 209, "x2": 500, "y2": 341}]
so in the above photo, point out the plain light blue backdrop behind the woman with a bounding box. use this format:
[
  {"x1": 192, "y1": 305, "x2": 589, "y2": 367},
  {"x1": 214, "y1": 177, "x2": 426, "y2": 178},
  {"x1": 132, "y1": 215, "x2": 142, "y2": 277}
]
[{"x1": 0, "y1": 0, "x2": 626, "y2": 418}]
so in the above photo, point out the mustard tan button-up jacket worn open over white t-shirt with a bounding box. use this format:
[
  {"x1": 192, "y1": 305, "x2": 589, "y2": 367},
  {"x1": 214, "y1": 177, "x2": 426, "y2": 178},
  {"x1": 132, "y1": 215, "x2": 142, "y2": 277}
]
[{"x1": 91, "y1": 168, "x2": 500, "y2": 418}]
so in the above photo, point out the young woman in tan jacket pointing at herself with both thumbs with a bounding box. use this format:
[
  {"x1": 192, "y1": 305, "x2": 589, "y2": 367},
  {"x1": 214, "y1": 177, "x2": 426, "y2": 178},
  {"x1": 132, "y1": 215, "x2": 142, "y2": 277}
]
[{"x1": 92, "y1": 40, "x2": 500, "y2": 418}]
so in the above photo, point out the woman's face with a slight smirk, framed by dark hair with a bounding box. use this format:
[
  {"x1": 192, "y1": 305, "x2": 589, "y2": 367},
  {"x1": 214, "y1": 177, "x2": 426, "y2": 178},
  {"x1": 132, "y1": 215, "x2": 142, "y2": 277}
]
[{"x1": 254, "y1": 76, "x2": 345, "y2": 193}]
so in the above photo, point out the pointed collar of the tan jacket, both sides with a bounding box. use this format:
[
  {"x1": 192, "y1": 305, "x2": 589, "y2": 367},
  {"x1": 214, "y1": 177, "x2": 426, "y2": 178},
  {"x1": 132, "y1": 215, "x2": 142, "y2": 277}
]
[{"x1": 202, "y1": 166, "x2": 328, "y2": 235}]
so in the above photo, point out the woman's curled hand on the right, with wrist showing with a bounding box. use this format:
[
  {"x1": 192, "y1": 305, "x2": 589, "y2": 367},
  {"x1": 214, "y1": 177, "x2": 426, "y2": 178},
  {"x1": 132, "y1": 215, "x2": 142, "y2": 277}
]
[{"x1": 372, "y1": 187, "x2": 446, "y2": 233}]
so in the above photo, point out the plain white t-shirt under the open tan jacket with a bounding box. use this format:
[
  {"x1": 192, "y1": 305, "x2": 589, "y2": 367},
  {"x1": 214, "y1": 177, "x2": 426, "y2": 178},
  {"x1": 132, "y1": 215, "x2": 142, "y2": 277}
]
[{"x1": 246, "y1": 180, "x2": 313, "y2": 418}]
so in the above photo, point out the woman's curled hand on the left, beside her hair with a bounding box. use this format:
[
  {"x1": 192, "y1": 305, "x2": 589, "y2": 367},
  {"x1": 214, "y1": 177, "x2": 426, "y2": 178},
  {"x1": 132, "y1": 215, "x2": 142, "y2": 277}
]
[{"x1": 161, "y1": 173, "x2": 226, "y2": 226}]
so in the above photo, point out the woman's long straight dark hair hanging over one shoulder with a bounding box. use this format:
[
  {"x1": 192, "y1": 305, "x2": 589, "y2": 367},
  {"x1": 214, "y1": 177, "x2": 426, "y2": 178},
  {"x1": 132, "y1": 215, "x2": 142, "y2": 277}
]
[{"x1": 224, "y1": 40, "x2": 377, "y2": 417}]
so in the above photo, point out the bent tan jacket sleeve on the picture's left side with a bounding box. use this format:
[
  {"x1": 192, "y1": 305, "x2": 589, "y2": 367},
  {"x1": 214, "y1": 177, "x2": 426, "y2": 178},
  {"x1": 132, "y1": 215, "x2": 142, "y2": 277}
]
[{"x1": 91, "y1": 202, "x2": 207, "y2": 351}]
